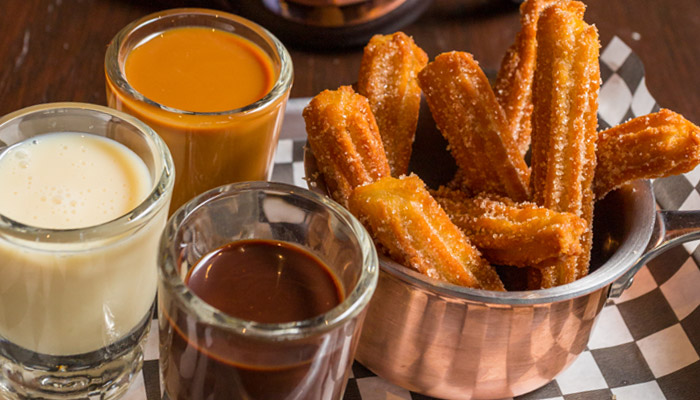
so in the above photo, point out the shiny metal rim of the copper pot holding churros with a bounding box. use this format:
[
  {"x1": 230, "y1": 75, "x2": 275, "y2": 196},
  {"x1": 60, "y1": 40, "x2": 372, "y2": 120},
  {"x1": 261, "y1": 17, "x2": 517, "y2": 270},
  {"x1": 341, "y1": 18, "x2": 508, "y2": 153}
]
[{"x1": 380, "y1": 180, "x2": 656, "y2": 306}]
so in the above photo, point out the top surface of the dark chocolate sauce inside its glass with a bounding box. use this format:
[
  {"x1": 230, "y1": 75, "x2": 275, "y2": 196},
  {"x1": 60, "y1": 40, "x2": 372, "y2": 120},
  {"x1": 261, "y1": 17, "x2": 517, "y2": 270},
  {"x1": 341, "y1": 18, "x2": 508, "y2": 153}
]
[{"x1": 185, "y1": 240, "x2": 342, "y2": 323}]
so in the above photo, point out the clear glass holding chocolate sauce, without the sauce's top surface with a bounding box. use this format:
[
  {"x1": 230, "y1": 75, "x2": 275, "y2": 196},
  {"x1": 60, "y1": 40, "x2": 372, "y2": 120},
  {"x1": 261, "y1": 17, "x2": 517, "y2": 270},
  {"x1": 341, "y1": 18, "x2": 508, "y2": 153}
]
[{"x1": 158, "y1": 182, "x2": 378, "y2": 400}]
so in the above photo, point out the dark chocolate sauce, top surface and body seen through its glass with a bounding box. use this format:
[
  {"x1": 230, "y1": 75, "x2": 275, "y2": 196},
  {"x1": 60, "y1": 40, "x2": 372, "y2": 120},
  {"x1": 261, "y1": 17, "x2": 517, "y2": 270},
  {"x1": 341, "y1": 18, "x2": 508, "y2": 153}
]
[{"x1": 161, "y1": 240, "x2": 343, "y2": 400}]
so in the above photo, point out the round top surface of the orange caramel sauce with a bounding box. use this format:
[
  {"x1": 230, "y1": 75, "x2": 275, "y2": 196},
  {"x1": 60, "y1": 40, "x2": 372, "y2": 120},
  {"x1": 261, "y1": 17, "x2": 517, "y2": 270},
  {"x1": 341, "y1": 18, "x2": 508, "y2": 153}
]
[{"x1": 124, "y1": 27, "x2": 275, "y2": 112}]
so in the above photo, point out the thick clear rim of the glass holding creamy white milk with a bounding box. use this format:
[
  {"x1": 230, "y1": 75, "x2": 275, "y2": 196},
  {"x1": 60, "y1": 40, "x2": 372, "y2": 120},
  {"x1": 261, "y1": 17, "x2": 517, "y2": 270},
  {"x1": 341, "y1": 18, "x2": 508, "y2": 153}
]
[{"x1": 0, "y1": 102, "x2": 175, "y2": 243}]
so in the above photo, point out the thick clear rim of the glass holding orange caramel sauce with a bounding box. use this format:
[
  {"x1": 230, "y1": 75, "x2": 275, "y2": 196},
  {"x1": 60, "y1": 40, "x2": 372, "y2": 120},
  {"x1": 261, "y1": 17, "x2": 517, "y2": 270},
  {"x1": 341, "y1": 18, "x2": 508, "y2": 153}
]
[{"x1": 105, "y1": 8, "x2": 294, "y2": 116}]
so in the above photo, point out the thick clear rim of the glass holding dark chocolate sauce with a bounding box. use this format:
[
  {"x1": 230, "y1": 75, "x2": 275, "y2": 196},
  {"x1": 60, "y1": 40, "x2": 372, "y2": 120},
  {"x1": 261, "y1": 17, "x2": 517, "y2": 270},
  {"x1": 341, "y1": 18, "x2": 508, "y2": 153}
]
[{"x1": 158, "y1": 181, "x2": 379, "y2": 340}]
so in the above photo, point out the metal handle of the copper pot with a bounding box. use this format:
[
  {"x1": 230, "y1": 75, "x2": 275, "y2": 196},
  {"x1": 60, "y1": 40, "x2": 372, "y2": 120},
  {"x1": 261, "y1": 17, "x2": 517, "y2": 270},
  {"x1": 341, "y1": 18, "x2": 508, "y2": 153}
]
[{"x1": 608, "y1": 210, "x2": 700, "y2": 297}]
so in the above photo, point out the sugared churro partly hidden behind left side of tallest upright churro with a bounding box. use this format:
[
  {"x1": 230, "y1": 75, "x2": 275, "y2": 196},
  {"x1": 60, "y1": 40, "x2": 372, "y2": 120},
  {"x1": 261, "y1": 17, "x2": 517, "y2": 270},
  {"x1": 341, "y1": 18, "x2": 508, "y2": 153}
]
[{"x1": 494, "y1": 0, "x2": 562, "y2": 154}]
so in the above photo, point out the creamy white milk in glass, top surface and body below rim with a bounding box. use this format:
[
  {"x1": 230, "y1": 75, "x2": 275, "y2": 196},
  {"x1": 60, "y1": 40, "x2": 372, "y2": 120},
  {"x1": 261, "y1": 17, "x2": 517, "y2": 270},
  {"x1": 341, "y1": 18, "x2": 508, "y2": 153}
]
[{"x1": 0, "y1": 133, "x2": 160, "y2": 355}]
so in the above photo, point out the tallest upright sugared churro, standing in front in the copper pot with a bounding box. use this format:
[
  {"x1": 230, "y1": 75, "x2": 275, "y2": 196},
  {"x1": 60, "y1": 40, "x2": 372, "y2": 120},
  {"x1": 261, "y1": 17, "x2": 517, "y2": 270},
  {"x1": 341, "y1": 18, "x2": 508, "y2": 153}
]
[{"x1": 531, "y1": 1, "x2": 600, "y2": 289}]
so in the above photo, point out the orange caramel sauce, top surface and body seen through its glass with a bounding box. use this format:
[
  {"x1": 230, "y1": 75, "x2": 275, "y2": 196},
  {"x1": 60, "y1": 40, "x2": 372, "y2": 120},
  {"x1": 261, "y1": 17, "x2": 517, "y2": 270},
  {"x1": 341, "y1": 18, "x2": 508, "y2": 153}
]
[{"x1": 107, "y1": 27, "x2": 289, "y2": 212}]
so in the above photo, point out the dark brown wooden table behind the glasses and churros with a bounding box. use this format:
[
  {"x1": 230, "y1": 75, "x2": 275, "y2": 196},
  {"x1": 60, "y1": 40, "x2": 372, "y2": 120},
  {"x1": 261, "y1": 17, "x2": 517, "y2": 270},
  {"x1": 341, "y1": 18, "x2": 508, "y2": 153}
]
[{"x1": 0, "y1": 0, "x2": 700, "y2": 123}]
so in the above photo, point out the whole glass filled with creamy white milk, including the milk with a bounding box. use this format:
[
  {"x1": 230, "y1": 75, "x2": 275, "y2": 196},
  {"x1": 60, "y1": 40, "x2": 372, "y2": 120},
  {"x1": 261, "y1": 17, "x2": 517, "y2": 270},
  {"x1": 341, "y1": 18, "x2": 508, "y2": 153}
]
[{"x1": 0, "y1": 103, "x2": 174, "y2": 399}]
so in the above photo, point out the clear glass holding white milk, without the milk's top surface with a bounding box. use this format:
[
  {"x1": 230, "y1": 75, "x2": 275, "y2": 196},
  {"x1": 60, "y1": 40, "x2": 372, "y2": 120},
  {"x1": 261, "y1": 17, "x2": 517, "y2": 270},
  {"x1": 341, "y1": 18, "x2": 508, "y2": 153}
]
[{"x1": 0, "y1": 103, "x2": 174, "y2": 399}]
